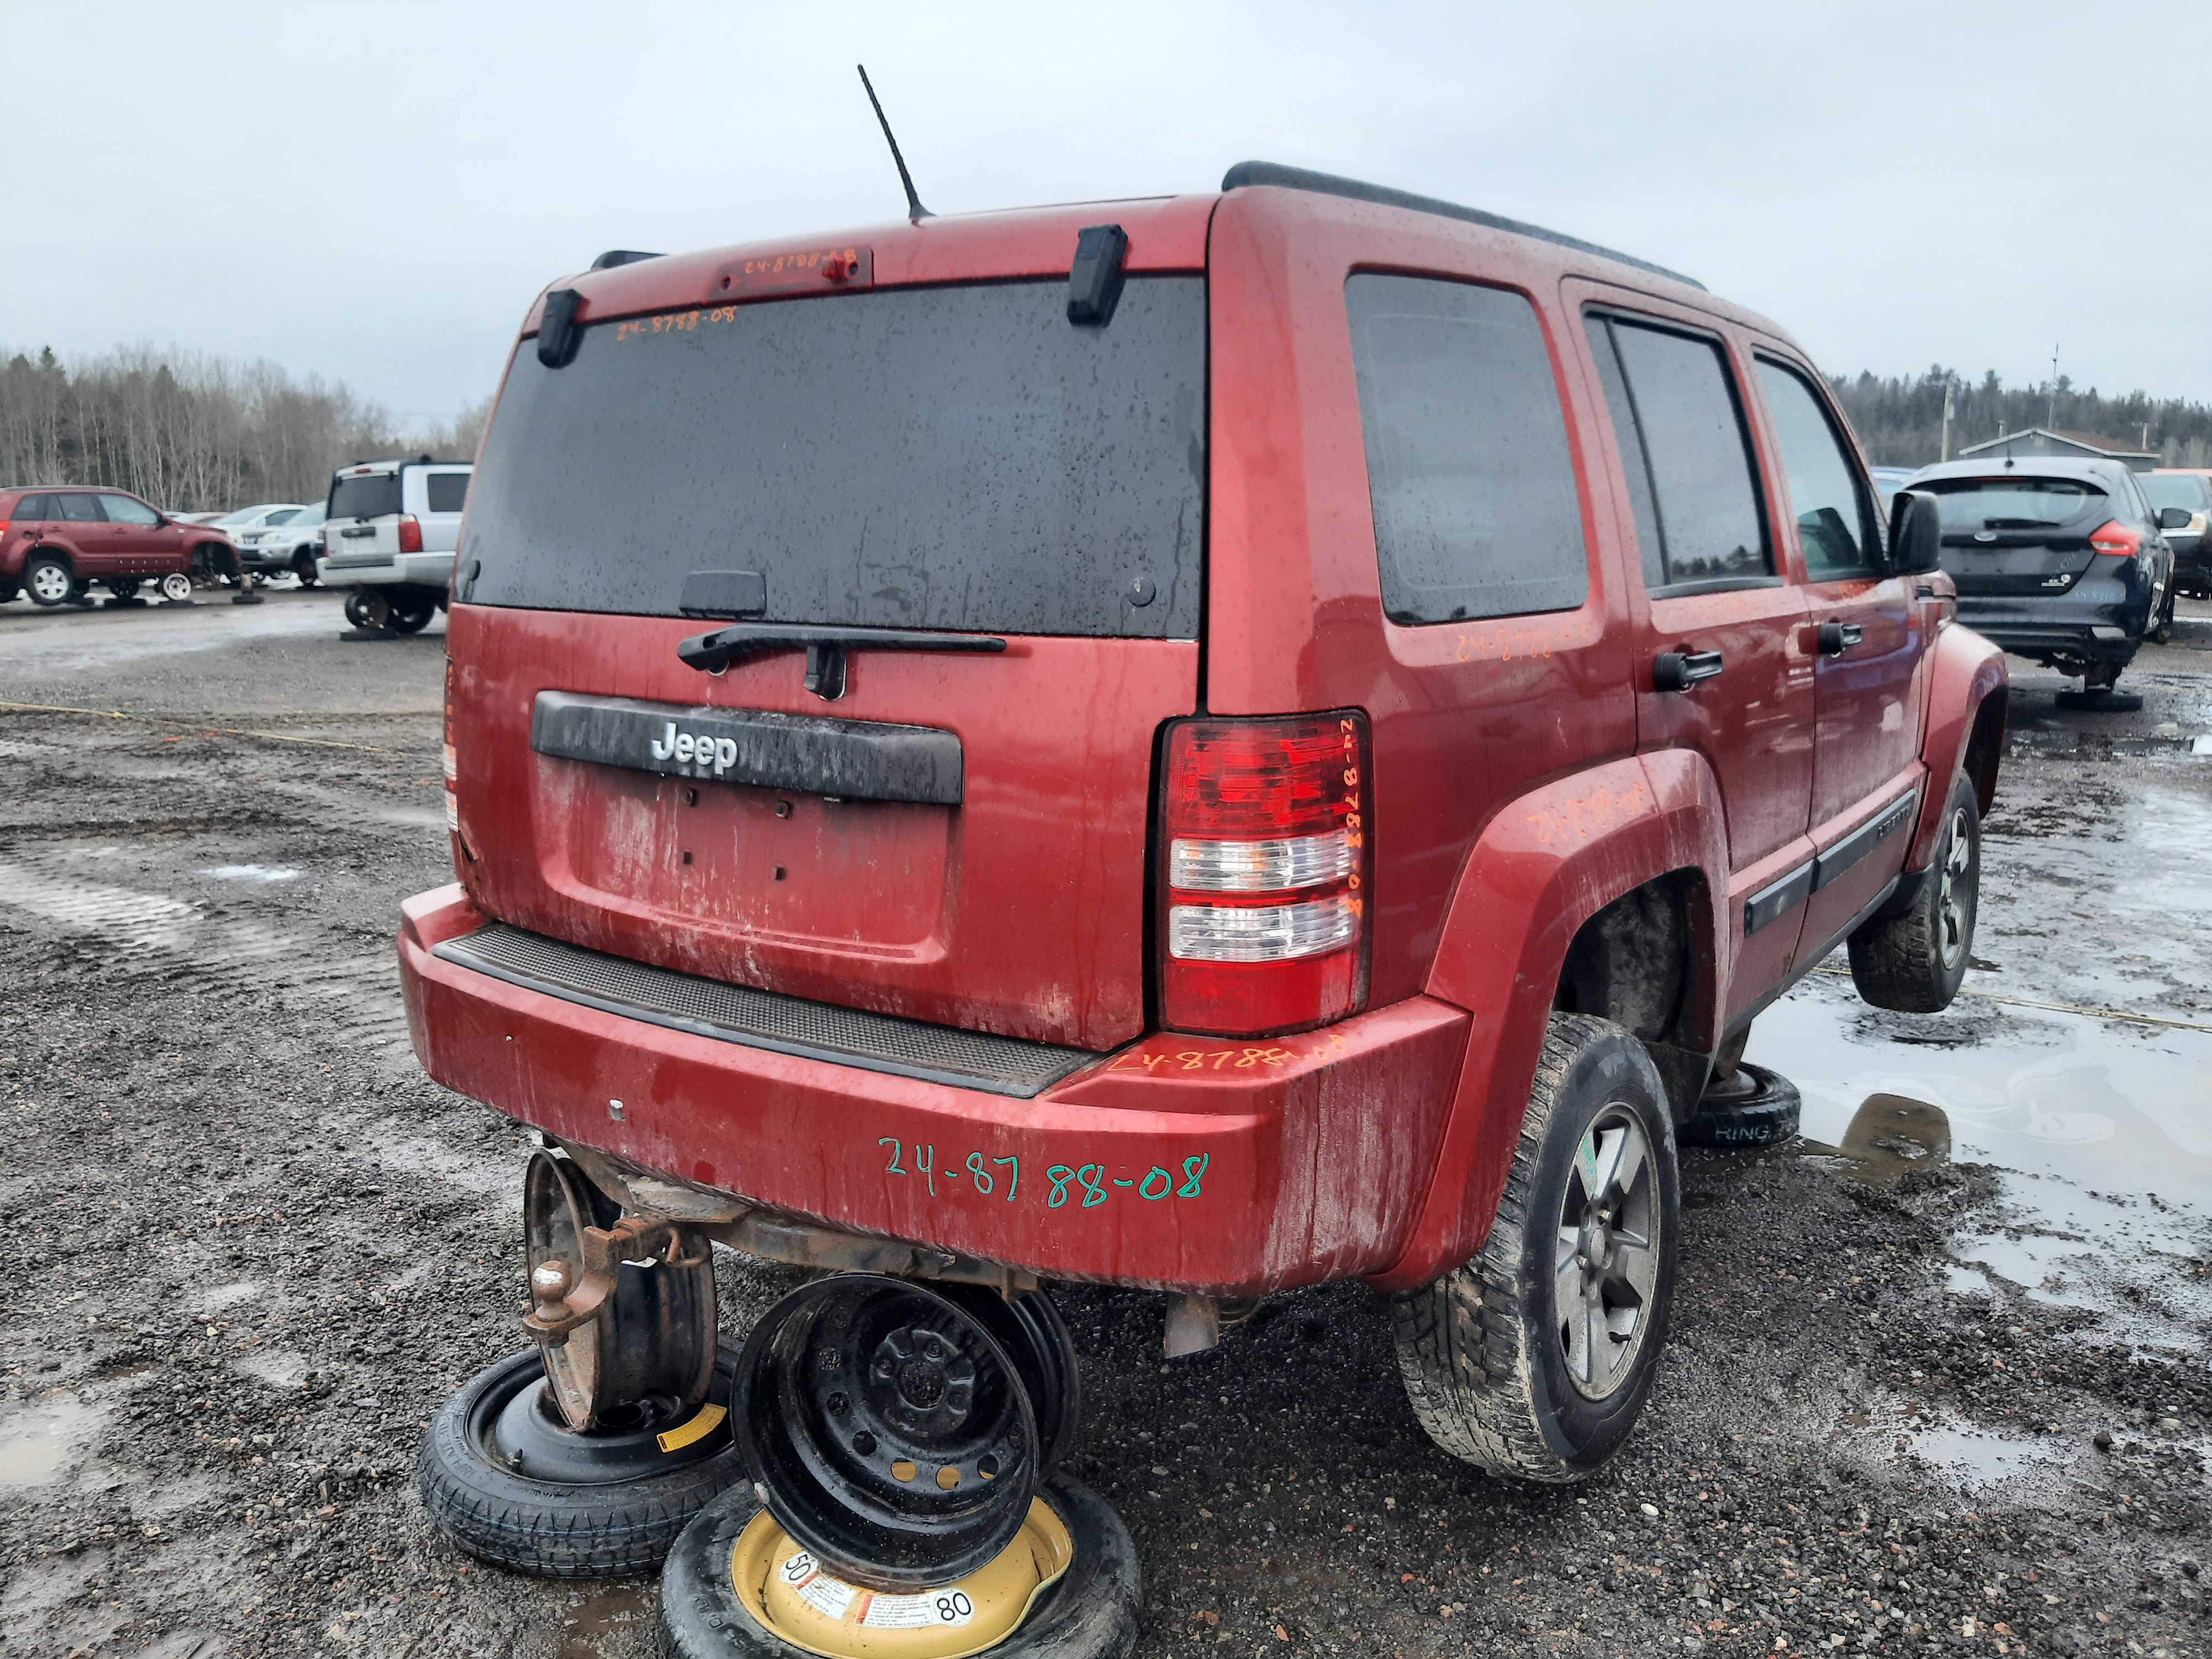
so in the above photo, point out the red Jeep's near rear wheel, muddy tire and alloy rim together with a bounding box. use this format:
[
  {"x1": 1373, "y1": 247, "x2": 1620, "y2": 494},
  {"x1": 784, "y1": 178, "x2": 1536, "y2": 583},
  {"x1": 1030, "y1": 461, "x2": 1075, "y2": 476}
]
[{"x1": 1391, "y1": 1013, "x2": 1681, "y2": 1482}]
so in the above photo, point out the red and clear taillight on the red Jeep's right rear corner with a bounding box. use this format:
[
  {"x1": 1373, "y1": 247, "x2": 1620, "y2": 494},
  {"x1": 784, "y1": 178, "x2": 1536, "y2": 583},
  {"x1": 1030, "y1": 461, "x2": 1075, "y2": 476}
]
[{"x1": 1159, "y1": 712, "x2": 1367, "y2": 1037}]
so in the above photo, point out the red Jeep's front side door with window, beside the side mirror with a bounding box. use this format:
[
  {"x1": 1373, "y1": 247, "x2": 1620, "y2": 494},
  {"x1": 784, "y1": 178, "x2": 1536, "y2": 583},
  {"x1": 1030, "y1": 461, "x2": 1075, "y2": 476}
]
[{"x1": 1754, "y1": 349, "x2": 1936, "y2": 951}]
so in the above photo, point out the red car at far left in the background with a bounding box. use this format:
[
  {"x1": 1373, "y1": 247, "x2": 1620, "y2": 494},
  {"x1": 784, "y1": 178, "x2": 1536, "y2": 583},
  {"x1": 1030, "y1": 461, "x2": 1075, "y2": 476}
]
[{"x1": 0, "y1": 484, "x2": 237, "y2": 606}]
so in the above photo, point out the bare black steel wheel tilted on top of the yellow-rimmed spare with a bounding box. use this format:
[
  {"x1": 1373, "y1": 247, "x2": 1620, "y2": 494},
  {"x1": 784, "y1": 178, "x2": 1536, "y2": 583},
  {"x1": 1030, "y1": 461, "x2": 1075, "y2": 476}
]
[{"x1": 737, "y1": 1274, "x2": 1044, "y2": 1590}]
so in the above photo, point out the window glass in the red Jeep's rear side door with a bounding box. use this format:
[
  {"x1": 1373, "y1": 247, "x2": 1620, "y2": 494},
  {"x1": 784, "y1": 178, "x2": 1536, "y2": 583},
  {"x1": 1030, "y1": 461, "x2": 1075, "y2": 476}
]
[{"x1": 1588, "y1": 314, "x2": 1774, "y2": 588}]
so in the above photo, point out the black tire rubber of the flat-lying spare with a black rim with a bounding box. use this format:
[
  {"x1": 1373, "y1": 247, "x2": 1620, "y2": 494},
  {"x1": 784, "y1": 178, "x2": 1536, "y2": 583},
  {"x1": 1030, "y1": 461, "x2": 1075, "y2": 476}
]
[{"x1": 416, "y1": 1343, "x2": 745, "y2": 1579}]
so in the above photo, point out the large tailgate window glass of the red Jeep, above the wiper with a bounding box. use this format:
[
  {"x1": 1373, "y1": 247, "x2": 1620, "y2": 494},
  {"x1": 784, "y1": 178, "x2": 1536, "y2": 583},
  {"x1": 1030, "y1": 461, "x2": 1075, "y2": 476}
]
[{"x1": 458, "y1": 276, "x2": 1206, "y2": 639}]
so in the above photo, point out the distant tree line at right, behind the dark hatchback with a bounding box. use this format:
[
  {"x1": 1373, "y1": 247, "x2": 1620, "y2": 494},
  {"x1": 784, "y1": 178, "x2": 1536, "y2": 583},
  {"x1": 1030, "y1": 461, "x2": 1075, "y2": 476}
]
[{"x1": 1829, "y1": 363, "x2": 2212, "y2": 467}]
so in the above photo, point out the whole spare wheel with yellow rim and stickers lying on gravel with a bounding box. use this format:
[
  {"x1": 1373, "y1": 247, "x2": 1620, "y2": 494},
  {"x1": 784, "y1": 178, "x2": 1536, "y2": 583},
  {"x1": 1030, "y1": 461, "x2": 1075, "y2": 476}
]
[{"x1": 659, "y1": 1475, "x2": 1144, "y2": 1659}]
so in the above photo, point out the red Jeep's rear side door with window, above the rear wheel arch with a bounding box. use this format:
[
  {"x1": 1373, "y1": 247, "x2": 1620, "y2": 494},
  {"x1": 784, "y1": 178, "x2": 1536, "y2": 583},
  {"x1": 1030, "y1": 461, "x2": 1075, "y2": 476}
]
[{"x1": 1568, "y1": 296, "x2": 1814, "y2": 1020}]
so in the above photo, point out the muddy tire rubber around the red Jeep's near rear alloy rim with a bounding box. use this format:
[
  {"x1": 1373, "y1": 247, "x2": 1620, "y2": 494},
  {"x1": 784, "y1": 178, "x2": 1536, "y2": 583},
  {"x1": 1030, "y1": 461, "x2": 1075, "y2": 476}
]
[{"x1": 1391, "y1": 1013, "x2": 1681, "y2": 1482}]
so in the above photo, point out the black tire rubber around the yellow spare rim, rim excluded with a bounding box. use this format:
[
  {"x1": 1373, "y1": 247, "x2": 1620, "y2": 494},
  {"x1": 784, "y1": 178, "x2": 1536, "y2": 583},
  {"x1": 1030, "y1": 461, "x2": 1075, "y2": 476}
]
[{"x1": 659, "y1": 1475, "x2": 1144, "y2": 1659}]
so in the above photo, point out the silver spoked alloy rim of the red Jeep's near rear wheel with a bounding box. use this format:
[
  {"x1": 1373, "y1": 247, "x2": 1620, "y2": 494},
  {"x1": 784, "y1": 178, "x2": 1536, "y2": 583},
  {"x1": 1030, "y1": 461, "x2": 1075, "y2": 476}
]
[{"x1": 1553, "y1": 1102, "x2": 1661, "y2": 1400}]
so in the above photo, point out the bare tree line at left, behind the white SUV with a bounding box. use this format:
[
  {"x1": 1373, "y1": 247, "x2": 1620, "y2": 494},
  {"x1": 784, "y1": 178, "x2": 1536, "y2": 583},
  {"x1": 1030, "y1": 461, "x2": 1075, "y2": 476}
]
[{"x1": 0, "y1": 345, "x2": 491, "y2": 513}]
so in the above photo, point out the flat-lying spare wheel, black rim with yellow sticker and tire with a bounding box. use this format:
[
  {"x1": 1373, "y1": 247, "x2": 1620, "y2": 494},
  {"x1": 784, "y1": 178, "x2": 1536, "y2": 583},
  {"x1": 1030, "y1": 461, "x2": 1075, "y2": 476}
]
[{"x1": 416, "y1": 1343, "x2": 743, "y2": 1579}]
